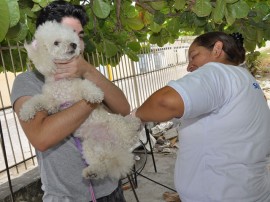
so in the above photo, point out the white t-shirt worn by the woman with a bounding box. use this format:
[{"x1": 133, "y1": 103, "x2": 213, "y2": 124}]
[{"x1": 168, "y1": 63, "x2": 270, "y2": 202}]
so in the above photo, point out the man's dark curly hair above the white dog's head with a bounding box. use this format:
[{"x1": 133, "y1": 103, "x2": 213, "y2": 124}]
[{"x1": 36, "y1": 0, "x2": 88, "y2": 28}]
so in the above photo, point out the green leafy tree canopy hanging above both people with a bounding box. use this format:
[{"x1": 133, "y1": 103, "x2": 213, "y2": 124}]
[{"x1": 0, "y1": 0, "x2": 270, "y2": 72}]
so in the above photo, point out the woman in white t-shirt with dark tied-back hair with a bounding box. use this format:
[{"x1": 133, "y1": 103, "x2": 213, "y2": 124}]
[{"x1": 133, "y1": 32, "x2": 270, "y2": 202}]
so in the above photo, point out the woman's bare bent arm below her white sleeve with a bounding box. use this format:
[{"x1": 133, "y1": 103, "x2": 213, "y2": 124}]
[{"x1": 135, "y1": 86, "x2": 184, "y2": 122}]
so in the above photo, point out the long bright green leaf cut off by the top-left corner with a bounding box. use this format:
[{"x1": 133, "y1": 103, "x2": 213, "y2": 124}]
[{"x1": 0, "y1": 0, "x2": 10, "y2": 42}]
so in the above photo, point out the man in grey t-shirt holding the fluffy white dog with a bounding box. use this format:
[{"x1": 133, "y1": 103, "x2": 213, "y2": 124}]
[{"x1": 11, "y1": 1, "x2": 130, "y2": 202}]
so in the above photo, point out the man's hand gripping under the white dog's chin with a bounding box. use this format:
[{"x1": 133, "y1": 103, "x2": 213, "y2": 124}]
[{"x1": 54, "y1": 55, "x2": 91, "y2": 80}]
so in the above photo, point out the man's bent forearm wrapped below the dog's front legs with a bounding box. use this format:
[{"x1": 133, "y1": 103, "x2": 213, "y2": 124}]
[{"x1": 14, "y1": 96, "x2": 96, "y2": 151}]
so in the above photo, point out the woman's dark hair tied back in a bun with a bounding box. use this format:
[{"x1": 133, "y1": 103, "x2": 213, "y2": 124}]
[{"x1": 193, "y1": 32, "x2": 246, "y2": 65}]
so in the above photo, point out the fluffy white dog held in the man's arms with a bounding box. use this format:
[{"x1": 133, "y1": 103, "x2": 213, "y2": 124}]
[{"x1": 20, "y1": 22, "x2": 140, "y2": 179}]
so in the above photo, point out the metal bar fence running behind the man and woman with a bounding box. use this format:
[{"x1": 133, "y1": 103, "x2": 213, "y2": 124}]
[{"x1": 0, "y1": 38, "x2": 192, "y2": 197}]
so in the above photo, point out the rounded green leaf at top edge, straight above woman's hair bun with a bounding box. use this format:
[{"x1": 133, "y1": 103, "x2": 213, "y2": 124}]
[{"x1": 227, "y1": 0, "x2": 250, "y2": 18}]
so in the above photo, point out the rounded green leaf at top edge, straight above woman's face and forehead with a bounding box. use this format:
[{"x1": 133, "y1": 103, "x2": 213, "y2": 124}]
[{"x1": 192, "y1": 0, "x2": 212, "y2": 17}]
